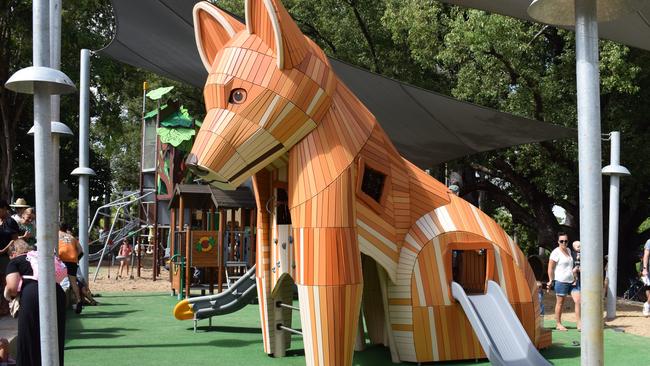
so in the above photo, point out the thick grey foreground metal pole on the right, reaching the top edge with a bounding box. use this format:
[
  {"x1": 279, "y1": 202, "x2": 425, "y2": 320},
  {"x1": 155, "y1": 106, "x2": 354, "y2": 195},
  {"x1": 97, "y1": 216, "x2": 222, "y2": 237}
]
[{"x1": 575, "y1": 0, "x2": 603, "y2": 366}]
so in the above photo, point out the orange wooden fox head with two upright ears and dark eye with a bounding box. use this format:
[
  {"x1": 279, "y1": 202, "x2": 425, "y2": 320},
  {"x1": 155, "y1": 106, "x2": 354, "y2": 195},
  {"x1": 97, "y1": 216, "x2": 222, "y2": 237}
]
[{"x1": 186, "y1": 0, "x2": 336, "y2": 189}]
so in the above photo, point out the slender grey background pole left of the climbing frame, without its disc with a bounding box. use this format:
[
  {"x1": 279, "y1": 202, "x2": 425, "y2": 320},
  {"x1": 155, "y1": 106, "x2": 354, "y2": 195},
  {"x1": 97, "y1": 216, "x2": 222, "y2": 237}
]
[{"x1": 78, "y1": 49, "x2": 90, "y2": 279}]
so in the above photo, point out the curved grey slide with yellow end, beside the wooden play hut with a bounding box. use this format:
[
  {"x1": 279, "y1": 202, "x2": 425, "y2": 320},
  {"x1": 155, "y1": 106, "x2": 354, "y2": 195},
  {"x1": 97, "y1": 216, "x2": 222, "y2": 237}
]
[{"x1": 174, "y1": 266, "x2": 257, "y2": 320}]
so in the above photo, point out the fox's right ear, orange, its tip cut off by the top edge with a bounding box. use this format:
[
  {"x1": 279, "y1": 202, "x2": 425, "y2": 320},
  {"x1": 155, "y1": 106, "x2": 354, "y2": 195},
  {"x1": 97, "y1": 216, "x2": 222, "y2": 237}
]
[{"x1": 246, "y1": 0, "x2": 309, "y2": 70}]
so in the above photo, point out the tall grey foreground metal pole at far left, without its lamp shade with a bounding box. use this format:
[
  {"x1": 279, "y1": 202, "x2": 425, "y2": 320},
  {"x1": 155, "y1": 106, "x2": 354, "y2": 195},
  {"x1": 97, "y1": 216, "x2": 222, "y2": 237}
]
[{"x1": 33, "y1": 0, "x2": 59, "y2": 366}]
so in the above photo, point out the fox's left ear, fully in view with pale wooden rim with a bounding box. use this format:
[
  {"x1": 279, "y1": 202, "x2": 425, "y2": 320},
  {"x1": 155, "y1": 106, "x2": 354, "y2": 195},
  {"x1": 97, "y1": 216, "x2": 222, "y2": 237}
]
[{"x1": 193, "y1": 1, "x2": 244, "y2": 71}]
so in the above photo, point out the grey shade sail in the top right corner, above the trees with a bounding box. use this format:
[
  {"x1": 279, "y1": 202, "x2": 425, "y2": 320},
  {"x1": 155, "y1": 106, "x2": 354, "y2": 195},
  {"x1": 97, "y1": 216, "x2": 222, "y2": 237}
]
[{"x1": 438, "y1": 0, "x2": 650, "y2": 50}]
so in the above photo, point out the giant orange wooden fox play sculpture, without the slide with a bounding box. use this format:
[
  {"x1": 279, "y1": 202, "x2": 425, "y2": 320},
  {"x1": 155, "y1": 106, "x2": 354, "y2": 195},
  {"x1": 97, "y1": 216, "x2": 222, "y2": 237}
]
[{"x1": 187, "y1": 0, "x2": 550, "y2": 366}]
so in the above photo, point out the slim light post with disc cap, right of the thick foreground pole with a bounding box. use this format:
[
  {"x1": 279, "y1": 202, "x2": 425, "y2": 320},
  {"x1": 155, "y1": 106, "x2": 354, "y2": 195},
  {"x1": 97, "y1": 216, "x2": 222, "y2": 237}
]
[{"x1": 602, "y1": 131, "x2": 630, "y2": 320}]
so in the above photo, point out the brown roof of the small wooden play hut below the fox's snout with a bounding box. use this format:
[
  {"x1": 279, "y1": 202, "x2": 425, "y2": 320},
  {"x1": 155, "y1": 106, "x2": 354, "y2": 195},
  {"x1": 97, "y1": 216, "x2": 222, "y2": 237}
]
[{"x1": 169, "y1": 184, "x2": 256, "y2": 210}]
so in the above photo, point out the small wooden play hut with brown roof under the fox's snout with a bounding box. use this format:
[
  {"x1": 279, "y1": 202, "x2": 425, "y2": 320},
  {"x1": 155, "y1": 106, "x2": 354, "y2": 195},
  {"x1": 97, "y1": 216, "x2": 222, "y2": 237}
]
[{"x1": 169, "y1": 184, "x2": 256, "y2": 298}]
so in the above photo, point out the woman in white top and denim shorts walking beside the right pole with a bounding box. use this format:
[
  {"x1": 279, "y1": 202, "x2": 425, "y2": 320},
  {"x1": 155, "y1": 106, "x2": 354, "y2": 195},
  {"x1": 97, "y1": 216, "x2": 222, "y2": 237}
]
[{"x1": 548, "y1": 233, "x2": 580, "y2": 331}]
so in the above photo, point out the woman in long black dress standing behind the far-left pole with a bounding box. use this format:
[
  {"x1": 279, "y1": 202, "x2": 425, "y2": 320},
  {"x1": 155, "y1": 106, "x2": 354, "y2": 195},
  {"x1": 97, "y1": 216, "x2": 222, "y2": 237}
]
[{"x1": 5, "y1": 239, "x2": 65, "y2": 366}]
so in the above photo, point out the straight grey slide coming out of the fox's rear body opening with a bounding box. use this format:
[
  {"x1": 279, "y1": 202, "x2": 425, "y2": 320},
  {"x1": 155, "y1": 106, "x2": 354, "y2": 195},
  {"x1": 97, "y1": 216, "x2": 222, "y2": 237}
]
[{"x1": 451, "y1": 281, "x2": 551, "y2": 366}]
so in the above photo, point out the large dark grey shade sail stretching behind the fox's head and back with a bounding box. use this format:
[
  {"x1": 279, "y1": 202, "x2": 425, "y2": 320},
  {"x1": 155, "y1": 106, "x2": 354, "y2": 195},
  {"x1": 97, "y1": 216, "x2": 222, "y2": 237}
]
[{"x1": 100, "y1": 0, "x2": 575, "y2": 168}]
